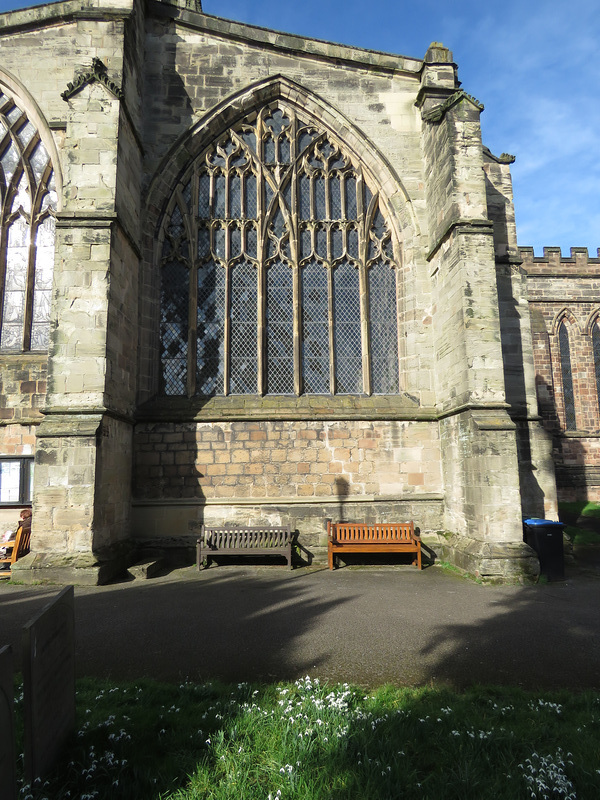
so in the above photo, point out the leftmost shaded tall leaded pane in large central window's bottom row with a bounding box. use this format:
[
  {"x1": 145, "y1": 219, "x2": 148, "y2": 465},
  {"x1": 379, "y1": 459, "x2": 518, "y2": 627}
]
[{"x1": 160, "y1": 261, "x2": 189, "y2": 395}]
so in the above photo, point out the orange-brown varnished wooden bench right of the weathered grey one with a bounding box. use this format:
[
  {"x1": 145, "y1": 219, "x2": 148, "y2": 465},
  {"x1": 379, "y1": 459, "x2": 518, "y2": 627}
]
[{"x1": 327, "y1": 520, "x2": 422, "y2": 569}]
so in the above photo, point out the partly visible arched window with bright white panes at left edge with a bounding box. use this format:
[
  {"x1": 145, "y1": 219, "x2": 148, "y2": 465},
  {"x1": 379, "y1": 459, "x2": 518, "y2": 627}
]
[{"x1": 0, "y1": 92, "x2": 57, "y2": 352}]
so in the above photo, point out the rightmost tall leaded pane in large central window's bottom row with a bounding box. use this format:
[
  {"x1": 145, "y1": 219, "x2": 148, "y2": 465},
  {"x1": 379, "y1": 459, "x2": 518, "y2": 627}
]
[{"x1": 368, "y1": 261, "x2": 399, "y2": 394}]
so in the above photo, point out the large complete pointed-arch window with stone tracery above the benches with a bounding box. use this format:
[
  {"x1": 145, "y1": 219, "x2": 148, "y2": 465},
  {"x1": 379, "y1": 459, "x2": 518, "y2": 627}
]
[{"x1": 160, "y1": 103, "x2": 399, "y2": 396}]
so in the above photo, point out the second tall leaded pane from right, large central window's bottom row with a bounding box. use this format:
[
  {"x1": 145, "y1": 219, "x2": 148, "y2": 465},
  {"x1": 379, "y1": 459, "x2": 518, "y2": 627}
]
[{"x1": 333, "y1": 262, "x2": 362, "y2": 394}]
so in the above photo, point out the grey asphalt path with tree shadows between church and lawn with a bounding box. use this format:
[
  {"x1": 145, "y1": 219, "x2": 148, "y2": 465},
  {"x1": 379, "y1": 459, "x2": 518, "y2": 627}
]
[{"x1": 0, "y1": 566, "x2": 600, "y2": 689}]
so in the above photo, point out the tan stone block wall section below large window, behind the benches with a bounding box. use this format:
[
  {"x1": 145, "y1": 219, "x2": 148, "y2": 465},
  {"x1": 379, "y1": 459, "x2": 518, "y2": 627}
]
[{"x1": 134, "y1": 420, "x2": 442, "y2": 560}]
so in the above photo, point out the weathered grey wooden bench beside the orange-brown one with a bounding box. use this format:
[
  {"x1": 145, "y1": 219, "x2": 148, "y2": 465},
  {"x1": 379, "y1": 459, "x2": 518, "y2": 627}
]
[{"x1": 196, "y1": 525, "x2": 295, "y2": 569}]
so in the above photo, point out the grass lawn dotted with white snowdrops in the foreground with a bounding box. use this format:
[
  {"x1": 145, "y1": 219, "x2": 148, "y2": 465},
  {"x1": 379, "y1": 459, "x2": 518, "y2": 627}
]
[{"x1": 11, "y1": 677, "x2": 600, "y2": 800}]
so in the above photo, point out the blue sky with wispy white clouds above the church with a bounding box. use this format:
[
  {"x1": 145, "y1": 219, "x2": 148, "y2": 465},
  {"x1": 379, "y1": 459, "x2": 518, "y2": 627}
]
[{"x1": 0, "y1": 0, "x2": 600, "y2": 255}]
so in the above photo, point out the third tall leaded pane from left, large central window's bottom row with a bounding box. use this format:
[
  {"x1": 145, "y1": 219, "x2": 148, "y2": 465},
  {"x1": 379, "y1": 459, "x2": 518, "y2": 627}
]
[{"x1": 230, "y1": 261, "x2": 258, "y2": 394}]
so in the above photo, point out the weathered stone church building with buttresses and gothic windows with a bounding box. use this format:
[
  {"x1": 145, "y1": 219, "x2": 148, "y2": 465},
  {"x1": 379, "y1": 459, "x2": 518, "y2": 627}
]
[{"x1": 0, "y1": 0, "x2": 600, "y2": 582}]
